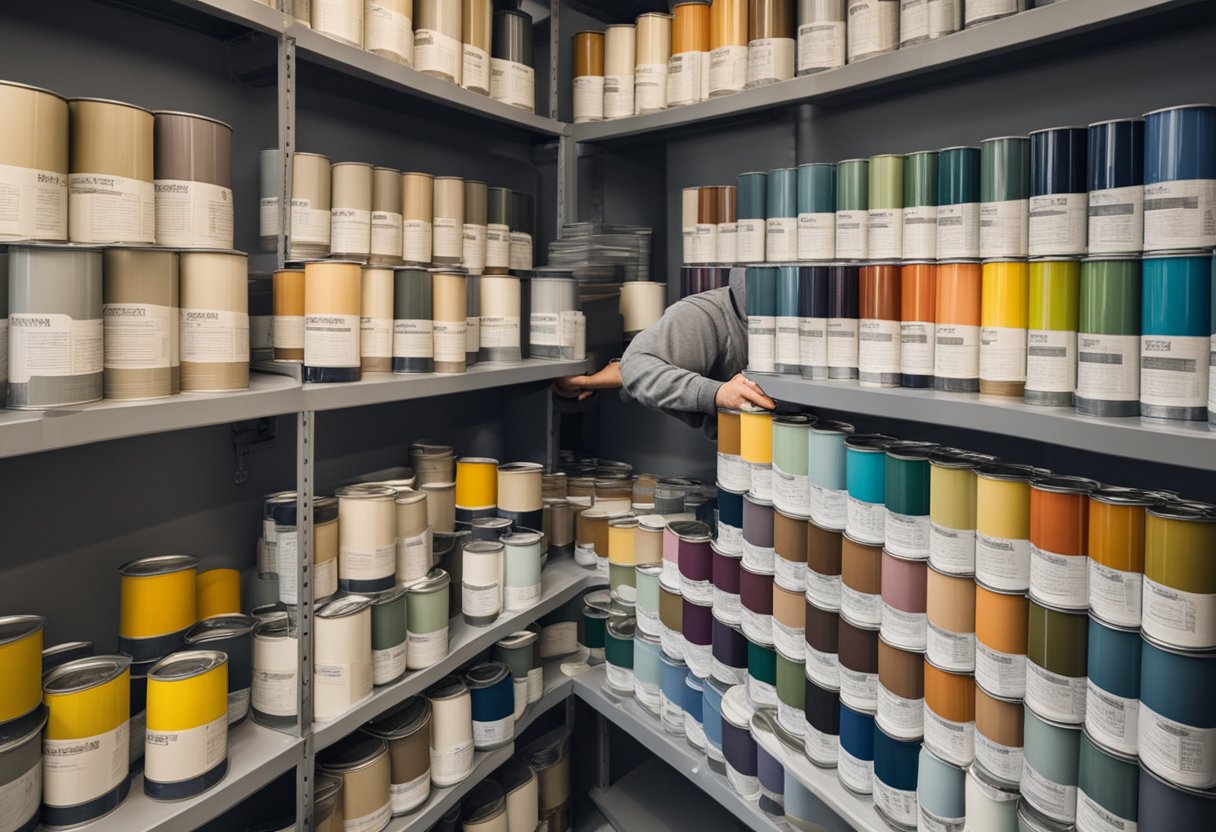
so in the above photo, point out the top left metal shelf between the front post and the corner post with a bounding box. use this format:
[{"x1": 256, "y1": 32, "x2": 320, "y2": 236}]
[{"x1": 286, "y1": 21, "x2": 570, "y2": 139}]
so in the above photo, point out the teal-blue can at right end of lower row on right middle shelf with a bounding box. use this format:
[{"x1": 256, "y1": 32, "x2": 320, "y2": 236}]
[{"x1": 1141, "y1": 251, "x2": 1212, "y2": 421}]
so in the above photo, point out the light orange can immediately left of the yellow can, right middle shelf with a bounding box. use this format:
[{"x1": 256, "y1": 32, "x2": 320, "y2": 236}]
[{"x1": 933, "y1": 260, "x2": 983, "y2": 393}]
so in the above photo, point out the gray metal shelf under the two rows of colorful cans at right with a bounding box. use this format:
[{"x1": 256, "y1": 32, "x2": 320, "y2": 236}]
[{"x1": 755, "y1": 374, "x2": 1216, "y2": 470}]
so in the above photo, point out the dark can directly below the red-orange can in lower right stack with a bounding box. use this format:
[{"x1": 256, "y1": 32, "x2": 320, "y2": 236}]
[{"x1": 1026, "y1": 601, "x2": 1088, "y2": 725}]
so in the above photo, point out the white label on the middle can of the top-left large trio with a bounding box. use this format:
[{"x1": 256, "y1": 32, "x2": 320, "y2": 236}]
[{"x1": 68, "y1": 173, "x2": 156, "y2": 243}]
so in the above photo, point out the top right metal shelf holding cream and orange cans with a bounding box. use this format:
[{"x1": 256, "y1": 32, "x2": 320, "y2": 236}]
[{"x1": 573, "y1": 0, "x2": 1203, "y2": 142}]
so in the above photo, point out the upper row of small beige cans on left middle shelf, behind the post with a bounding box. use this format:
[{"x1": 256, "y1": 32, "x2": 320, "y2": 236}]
[{"x1": 259, "y1": 148, "x2": 535, "y2": 275}]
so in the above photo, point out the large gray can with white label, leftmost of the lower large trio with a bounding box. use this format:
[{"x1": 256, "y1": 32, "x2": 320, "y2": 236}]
[{"x1": 7, "y1": 244, "x2": 103, "y2": 410}]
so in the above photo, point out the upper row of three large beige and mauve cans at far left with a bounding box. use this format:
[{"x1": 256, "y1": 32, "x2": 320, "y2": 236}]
[{"x1": 0, "y1": 81, "x2": 233, "y2": 249}]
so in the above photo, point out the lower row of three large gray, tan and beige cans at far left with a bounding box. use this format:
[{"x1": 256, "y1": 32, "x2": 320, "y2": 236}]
[{"x1": 5, "y1": 243, "x2": 249, "y2": 410}]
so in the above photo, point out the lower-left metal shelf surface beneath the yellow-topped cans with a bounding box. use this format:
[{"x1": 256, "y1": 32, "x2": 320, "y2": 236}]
[{"x1": 39, "y1": 718, "x2": 304, "y2": 832}]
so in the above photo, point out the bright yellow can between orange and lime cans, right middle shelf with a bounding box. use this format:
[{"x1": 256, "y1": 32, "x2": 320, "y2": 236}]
[{"x1": 980, "y1": 260, "x2": 1030, "y2": 397}]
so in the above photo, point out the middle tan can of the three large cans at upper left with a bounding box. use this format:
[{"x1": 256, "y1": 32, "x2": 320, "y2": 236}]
[{"x1": 68, "y1": 99, "x2": 156, "y2": 243}]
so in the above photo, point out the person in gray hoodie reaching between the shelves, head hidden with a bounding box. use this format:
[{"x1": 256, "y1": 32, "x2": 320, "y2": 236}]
[{"x1": 556, "y1": 269, "x2": 776, "y2": 431}]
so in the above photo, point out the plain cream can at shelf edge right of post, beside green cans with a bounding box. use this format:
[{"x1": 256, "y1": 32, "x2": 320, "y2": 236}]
[{"x1": 313, "y1": 595, "x2": 372, "y2": 723}]
